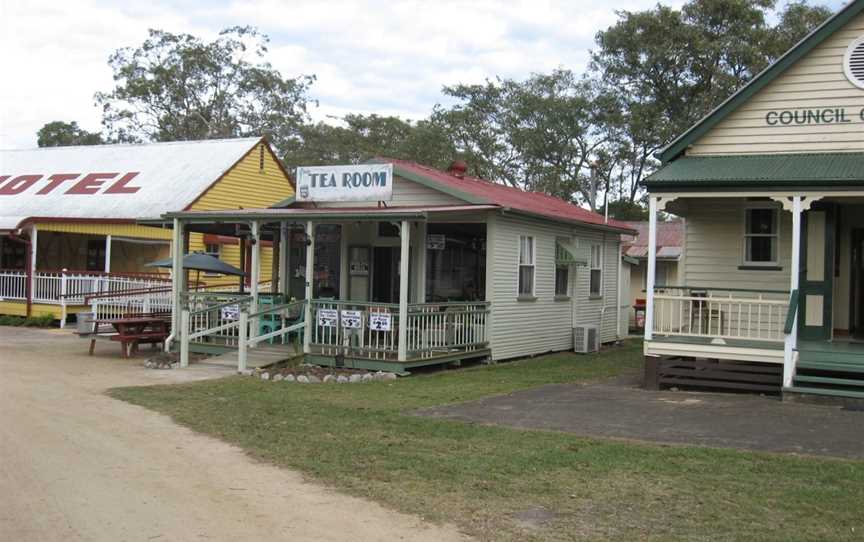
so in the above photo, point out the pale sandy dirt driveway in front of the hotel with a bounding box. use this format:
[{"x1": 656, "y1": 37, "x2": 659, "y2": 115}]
[{"x1": 0, "y1": 327, "x2": 465, "y2": 542}]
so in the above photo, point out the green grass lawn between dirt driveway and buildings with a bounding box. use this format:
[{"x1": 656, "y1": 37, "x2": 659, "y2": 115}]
[{"x1": 111, "y1": 342, "x2": 864, "y2": 541}]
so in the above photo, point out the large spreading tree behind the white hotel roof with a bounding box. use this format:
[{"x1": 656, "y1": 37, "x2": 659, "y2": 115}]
[{"x1": 96, "y1": 27, "x2": 314, "y2": 153}]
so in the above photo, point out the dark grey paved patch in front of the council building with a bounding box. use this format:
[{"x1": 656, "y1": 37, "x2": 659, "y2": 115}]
[{"x1": 419, "y1": 380, "x2": 864, "y2": 459}]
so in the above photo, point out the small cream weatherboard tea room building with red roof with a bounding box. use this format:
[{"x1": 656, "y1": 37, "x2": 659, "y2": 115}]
[{"x1": 157, "y1": 160, "x2": 632, "y2": 372}]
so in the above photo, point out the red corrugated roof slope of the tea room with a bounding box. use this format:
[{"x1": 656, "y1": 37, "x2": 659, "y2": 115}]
[{"x1": 379, "y1": 158, "x2": 631, "y2": 234}]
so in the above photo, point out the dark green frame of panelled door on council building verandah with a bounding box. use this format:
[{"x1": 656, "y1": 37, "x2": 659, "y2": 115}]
[{"x1": 798, "y1": 203, "x2": 835, "y2": 341}]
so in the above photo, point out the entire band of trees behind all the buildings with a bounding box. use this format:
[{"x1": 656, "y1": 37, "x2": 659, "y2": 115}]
[{"x1": 38, "y1": 0, "x2": 831, "y2": 221}]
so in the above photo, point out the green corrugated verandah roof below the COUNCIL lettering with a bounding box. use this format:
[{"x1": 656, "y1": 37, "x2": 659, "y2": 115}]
[{"x1": 645, "y1": 152, "x2": 864, "y2": 189}]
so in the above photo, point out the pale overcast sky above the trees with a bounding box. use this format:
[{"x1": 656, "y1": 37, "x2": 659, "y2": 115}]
[{"x1": 0, "y1": 0, "x2": 840, "y2": 149}]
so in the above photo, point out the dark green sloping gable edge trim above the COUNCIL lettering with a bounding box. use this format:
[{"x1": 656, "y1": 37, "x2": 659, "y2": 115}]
[{"x1": 658, "y1": 0, "x2": 864, "y2": 164}]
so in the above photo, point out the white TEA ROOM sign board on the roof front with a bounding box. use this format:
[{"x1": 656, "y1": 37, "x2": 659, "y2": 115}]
[{"x1": 296, "y1": 164, "x2": 393, "y2": 201}]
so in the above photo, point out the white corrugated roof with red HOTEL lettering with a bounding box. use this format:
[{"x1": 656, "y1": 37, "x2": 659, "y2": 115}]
[{"x1": 0, "y1": 137, "x2": 261, "y2": 230}]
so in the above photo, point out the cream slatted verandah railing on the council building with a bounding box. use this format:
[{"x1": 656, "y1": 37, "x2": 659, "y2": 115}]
[{"x1": 652, "y1": 286, "x2": 789, "y2": 343}]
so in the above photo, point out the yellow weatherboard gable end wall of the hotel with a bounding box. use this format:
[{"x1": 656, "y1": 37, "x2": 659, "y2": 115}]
[{"x1": 189, "y1": 143, "x2": 294, "y2": 284}]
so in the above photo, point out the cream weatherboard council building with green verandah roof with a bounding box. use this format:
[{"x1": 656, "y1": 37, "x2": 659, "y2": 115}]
[{"x1": 645, "y1": 0, "x2": 864, "y2": 399}]
